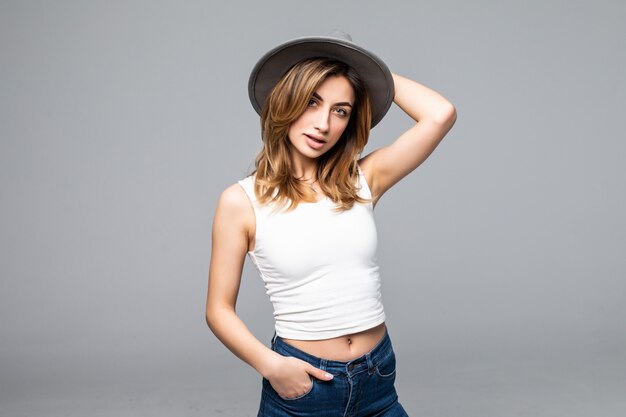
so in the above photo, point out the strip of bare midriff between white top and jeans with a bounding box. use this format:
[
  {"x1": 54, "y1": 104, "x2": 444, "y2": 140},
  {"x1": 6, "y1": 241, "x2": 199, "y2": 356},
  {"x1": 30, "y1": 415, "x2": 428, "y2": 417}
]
[{"x1": 283, "y1": 323, "x2": 386, "y2": 362}]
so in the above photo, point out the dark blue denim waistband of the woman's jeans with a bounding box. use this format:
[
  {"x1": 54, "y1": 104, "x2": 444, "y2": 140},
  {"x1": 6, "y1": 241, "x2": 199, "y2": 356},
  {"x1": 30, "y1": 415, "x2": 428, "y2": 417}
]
[{"x1": 272, "y1": 331, "x2": 393, "y2": 375}]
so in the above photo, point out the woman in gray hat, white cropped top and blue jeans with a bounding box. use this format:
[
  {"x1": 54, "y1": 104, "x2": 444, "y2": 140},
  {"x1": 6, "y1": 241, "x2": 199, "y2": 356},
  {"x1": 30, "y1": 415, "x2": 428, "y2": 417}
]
[{"x1": 206, "y1": 32, "x2": 456, "y2": 417}]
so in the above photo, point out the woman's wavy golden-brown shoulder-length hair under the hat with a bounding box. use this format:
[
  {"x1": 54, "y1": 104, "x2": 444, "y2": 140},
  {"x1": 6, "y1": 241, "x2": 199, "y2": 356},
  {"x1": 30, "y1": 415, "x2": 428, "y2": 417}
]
[{"x1": 254, "y1": 58, "x2": 371, "y2": 211}]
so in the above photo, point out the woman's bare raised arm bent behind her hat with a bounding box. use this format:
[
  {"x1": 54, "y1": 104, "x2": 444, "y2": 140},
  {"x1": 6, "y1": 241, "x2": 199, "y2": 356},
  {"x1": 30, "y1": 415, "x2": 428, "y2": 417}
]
[{"x1": 359, "y1": 74, "x2": 456, "y2": 203}]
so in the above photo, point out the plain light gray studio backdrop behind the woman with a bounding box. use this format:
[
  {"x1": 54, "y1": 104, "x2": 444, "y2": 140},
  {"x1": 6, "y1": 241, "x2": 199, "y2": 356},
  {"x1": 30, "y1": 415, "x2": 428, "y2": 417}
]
[{"x1": 0, "y1": 0, "x2": 626, "y2": 417}]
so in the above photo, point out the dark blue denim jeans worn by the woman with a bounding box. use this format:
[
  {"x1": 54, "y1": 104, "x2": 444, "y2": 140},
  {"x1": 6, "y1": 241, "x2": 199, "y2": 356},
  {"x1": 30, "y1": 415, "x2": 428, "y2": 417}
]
[{"x1": 257, "y1": 334, "x2": 408, "y2": 417}]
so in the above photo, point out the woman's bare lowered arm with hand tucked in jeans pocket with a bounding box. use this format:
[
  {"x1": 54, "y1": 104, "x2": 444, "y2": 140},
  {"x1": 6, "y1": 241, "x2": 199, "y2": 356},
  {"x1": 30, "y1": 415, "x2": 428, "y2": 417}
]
[{"x1": 206, "y1": 184, "x2": 332, "y2": 398}]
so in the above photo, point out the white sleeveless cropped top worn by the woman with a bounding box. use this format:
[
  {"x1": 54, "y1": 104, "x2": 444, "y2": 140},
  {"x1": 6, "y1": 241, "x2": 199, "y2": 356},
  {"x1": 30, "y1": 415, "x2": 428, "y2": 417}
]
[{"x1": 239, "y1": 167, "x2": 385, "y2": 340}]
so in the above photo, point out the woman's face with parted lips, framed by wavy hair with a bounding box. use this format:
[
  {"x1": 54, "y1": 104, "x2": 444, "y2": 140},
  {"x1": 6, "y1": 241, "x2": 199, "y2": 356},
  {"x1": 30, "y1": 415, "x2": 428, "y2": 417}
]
[{"x1": 288, "y1": 76, "x2": 354, "y2": 163}]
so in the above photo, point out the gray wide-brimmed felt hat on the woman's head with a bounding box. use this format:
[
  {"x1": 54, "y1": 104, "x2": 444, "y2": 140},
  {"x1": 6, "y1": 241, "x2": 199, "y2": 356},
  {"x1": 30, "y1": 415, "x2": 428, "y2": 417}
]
[{"x1": 248, "y1": 31, "x2": 394, "y2": 127}]
